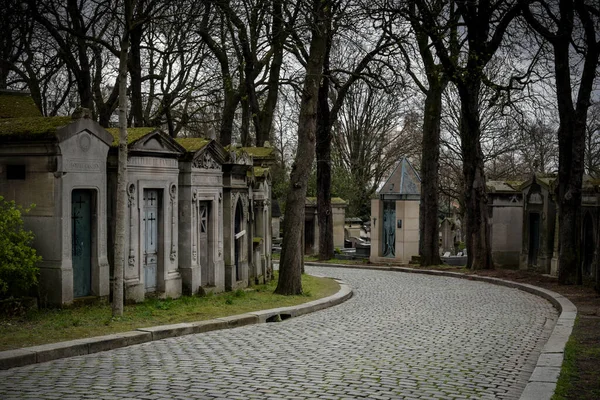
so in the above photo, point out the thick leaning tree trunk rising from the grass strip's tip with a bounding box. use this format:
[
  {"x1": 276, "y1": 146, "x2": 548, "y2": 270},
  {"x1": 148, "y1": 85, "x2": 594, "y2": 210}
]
[{"x1": 275, "y1": 0, "x2": 330, "y2": 295}]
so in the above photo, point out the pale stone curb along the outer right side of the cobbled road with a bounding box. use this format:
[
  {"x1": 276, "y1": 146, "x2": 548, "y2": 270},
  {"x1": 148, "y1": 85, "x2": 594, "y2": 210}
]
[{"x1": 305, "y1": 262, "x2": 577, "y2": 400}]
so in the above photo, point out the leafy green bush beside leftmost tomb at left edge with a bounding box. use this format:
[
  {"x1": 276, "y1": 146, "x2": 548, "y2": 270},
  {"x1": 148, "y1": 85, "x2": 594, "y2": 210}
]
[{"x1": 0, "y1": 196, "x2": 42, "y2": 299}]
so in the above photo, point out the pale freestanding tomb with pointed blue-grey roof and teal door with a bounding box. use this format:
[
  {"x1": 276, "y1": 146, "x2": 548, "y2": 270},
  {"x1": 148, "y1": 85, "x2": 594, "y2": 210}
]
[{"x1": 370, "y1": 158, "x2": 421, "y2": 264}]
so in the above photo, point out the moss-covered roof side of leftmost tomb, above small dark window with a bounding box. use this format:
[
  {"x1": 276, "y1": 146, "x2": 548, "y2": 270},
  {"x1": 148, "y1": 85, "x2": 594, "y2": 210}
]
[{"x1": 0, "y1": 117, "x2": 72, "y2": 141}]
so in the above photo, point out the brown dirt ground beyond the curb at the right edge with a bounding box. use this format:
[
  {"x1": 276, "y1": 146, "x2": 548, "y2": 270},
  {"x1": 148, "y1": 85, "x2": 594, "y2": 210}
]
[{"x1": 450, "y1": 269, "x2": 600, "y2": 400}]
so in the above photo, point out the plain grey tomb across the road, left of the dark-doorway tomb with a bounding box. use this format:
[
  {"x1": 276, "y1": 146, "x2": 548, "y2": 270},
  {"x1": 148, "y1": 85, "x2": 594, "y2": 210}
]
[{"x1": 487, "y1": 181, "x2": 523, "y2": 269}]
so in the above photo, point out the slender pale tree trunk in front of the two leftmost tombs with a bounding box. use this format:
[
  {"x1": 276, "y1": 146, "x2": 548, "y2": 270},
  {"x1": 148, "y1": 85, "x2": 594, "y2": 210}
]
[{"x1": 112, "y1": 0, "x2": 131, "y2": 316}]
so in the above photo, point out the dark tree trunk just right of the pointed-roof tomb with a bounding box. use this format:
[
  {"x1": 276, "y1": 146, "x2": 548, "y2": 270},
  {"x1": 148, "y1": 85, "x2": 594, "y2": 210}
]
[{"x1": 419, "y1": 79, "x2": 446, "y2": 266}]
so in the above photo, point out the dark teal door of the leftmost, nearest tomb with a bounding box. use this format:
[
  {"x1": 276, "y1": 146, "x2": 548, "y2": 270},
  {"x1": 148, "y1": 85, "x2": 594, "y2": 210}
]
[{"x1": 71, "y1": 190, "x2": 92, "y2": 297}]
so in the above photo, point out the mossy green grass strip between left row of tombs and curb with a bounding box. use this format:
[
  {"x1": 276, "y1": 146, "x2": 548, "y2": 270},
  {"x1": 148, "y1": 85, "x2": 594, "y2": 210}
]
[{"x1": 0, "y1": 275, "x2": 339, "y2": 351}]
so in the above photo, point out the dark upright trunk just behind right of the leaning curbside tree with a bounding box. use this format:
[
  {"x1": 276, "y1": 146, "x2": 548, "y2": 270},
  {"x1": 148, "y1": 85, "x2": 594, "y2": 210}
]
[{"x1": 316, "y1": 32, "x2": 334, "y2": 260}]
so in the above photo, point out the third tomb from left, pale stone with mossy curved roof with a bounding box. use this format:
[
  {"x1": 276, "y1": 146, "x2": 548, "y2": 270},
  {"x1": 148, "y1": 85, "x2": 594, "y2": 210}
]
[{"x1": 177, "y1": 138, "x2": 227, "y2": 295}]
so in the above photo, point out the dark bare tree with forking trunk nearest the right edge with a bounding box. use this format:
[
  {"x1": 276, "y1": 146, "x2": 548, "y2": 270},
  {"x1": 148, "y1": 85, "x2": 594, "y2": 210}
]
[{"x1": 521, "y1": 0, "x2": 600, "y2": 284}]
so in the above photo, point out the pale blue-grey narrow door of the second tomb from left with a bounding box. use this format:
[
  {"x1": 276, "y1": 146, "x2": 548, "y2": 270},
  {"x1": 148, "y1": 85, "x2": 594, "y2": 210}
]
[{"x1": 143, "y1": 189, "x2": 158, "y2": 292}]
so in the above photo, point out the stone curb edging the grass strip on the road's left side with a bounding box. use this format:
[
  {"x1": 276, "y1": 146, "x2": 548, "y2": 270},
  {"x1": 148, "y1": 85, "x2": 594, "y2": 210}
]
[{"x1": 0, "y1": 280, "x2": 352, "y2": 370}]
